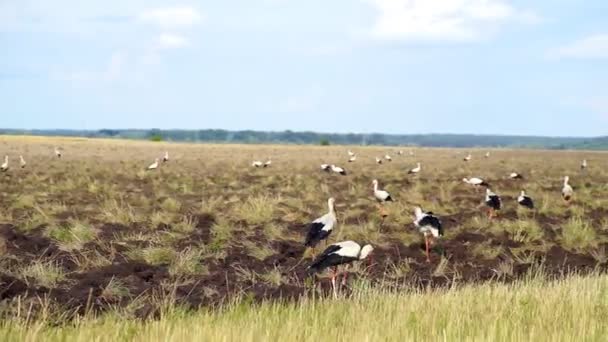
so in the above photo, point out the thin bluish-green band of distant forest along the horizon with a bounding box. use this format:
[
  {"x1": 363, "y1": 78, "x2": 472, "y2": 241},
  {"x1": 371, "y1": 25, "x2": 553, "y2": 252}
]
[{"x1": 0, "y1": 129, "x2": 608, "y2": 150}]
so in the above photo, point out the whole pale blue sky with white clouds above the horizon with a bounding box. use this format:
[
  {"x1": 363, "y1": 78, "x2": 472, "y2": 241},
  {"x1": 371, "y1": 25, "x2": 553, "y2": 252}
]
[{"x1": 0, "y1": 0, "x2": 608, "y2": 136}]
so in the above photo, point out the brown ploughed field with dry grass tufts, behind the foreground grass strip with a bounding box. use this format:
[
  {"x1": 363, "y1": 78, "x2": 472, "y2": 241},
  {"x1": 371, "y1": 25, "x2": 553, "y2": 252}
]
[{"x1": 0, "y1": 137, "x2": 608, "y2": 339}]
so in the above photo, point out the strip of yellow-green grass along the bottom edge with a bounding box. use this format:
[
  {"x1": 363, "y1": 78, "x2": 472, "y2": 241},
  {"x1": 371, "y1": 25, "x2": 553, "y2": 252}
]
[{"x1": 0, "y1": 276, "x2": 608, "y2": 341}]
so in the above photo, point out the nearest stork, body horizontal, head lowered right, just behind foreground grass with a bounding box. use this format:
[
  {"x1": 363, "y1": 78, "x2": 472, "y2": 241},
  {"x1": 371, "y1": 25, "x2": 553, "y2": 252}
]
[{"x1": 308, "y1": 240, "x2": 374, "y2": 298}]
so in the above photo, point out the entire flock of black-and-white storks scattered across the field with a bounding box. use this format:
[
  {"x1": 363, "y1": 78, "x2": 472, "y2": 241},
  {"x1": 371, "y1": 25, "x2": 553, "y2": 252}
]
[{"x1": 0, "y1": 148, "x2": 587, "y2": 295}]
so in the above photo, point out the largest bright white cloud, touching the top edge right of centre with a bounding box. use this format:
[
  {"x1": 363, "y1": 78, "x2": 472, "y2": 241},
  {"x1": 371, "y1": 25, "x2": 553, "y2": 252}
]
[{"x1": 366, "y1": 0, "x2": 538, "y2": 41}]
